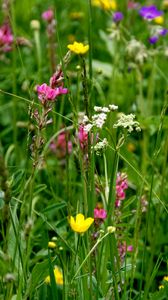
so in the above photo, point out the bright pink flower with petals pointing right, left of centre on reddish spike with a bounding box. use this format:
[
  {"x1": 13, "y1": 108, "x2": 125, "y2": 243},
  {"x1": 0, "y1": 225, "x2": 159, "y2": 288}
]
[{"x1": 37, "y1": 83, "x2": 68, "y2": 104}]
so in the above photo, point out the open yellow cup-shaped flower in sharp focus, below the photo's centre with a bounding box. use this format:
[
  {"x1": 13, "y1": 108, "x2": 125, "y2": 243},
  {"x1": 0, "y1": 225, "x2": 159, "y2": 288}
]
[{"x1": 69, "y1": 214, "x2": 94, "y2": 233}]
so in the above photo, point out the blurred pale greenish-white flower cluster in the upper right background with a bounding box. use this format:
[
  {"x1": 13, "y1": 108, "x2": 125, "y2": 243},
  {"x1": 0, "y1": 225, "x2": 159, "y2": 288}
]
[{"x1": 126, "y1": 39, "x2": 148, "y2": 64}]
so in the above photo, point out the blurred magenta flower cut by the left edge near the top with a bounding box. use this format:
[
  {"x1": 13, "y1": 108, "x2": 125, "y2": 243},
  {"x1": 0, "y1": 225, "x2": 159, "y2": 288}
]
[{"x1": 0, "y1": 24, "x2": 13, "y2": 52}]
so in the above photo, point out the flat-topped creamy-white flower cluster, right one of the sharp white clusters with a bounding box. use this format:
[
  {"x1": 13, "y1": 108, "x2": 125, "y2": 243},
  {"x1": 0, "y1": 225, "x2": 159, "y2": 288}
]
[{"x1": 113, "y1": 114, "x2": 141, "y2": 132}]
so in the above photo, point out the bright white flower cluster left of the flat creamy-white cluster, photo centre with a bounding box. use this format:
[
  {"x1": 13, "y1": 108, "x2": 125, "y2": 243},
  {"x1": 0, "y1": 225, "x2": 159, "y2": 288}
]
[{"x1": 83, "y1": 104, "x2": 118, "y2": 132}]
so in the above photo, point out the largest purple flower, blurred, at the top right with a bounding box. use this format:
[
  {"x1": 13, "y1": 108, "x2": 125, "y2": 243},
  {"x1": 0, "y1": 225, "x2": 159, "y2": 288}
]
[{"x1": 139, "y1": 5, "x2": 163, "y2": 20}]
